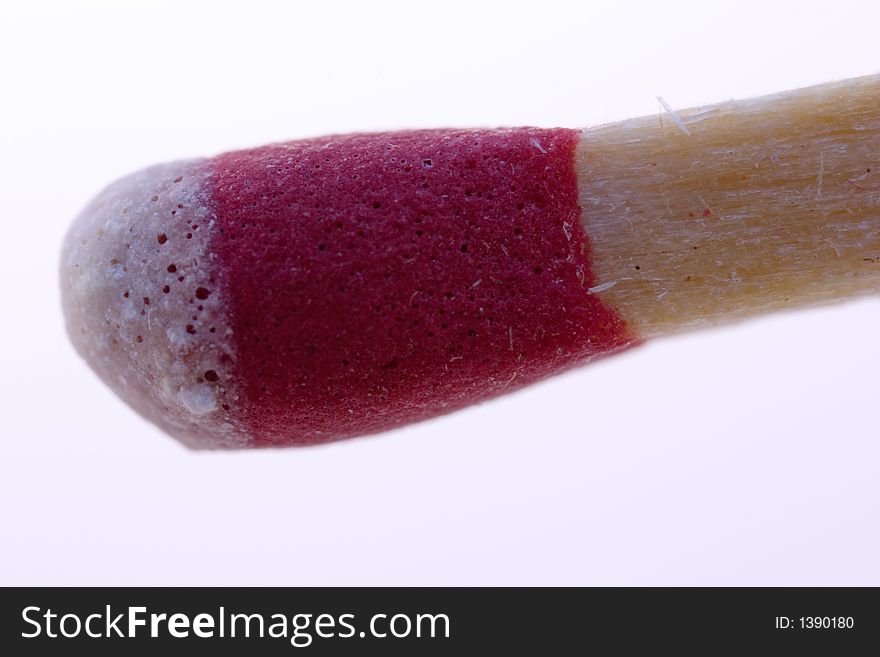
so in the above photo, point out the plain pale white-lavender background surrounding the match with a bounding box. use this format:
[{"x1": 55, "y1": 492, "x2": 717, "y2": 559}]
[{"x1": 0, "y1": 0, "x2": 880, "y2": 585}]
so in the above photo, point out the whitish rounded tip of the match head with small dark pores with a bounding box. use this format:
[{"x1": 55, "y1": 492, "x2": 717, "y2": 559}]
[{"x1": 61, "y1": 161, "x2": 247, "y2": 448}]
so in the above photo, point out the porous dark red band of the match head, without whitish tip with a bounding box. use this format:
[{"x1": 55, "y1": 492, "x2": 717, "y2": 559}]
[{"x1": 211, "y1": 128, "x2": 631, "y2": 445}]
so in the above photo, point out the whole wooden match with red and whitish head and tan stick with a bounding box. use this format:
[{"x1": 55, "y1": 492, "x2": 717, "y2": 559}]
[{"x1": 62, "y1": 76, "x2": 880, "y2": 447}]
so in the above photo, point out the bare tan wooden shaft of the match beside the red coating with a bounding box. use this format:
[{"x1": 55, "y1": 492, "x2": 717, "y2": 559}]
[{"x1": 576, "y1": 76, "x2": 880, "y2": 337}]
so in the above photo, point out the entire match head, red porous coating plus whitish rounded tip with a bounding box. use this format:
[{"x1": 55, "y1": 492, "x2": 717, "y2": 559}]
[{"x1": 62, "y1": 128, "x2": 633, "y2": 447}]
